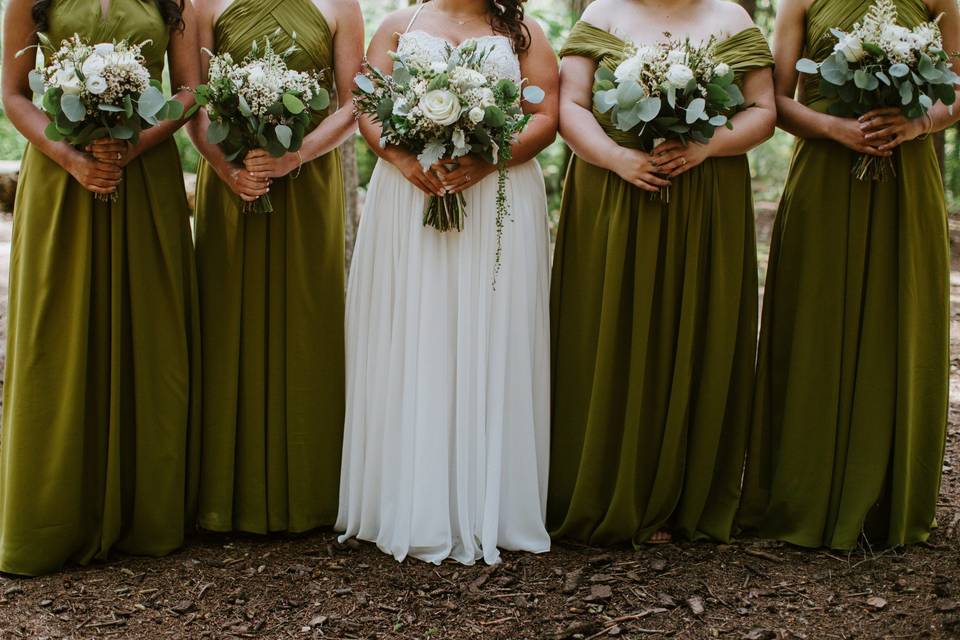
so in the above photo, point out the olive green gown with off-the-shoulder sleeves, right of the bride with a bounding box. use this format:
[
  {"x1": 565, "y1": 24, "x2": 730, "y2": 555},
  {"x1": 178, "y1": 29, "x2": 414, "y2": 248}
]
[{"x1": 548, "y1": 22, "x2": 772, "y2": 544}]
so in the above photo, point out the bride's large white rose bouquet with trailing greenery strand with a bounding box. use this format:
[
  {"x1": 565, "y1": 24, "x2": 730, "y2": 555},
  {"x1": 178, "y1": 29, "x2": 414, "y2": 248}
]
[{"x1": 354, "y1": 41, "x2": 544, "y2": 268}]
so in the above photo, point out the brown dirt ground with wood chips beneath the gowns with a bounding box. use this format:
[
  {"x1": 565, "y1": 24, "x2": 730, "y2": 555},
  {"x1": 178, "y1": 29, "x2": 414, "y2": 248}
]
[{"x1": 0, "y1": 208, "x2": 960, "y2": 640}]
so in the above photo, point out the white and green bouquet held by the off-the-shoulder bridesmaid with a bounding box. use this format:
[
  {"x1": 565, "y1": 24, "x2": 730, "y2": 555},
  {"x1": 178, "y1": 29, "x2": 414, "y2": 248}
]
[{"x1": 593, "y1": 34, "x2": 744, "y2": 200}]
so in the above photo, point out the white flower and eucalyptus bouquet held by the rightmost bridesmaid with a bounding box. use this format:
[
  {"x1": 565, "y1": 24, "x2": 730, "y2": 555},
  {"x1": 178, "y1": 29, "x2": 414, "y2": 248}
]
[{"x1": 797, "y1": 0, "x2": 960, "y2": 180}]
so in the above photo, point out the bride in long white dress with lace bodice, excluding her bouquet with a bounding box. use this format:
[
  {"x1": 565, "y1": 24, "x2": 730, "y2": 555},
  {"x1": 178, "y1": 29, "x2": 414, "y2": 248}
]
[{"x1": 337, "y1": 0, "x2": 558, "y2": 564}]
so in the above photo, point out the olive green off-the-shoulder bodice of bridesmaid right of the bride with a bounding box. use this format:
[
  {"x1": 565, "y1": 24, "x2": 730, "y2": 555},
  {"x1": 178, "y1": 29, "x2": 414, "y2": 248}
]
[{"x1": 560, "y1": 20, "x2": 773, "y2": 147}]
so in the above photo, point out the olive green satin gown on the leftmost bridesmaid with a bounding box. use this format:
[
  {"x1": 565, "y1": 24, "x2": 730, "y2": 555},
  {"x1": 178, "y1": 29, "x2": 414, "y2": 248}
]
[{"x1": 0, "y1": 0, "x2": 200, "y2": 575}]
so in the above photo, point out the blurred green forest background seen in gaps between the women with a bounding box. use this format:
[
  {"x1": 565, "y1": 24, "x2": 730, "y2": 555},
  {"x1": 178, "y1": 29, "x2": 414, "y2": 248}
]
[{"x1": 0, "y1": 0, "x2": 960, "y2": 218}]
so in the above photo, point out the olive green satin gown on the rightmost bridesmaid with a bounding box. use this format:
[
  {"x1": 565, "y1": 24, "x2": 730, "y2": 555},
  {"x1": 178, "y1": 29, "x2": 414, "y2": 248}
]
[{"x1": 740, "y1": 0, "x2": 950, "y2": 549}]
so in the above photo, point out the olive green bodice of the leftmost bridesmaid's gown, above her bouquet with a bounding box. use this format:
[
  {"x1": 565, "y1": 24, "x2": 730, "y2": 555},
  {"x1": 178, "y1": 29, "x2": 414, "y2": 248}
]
[{"x1": 46, "y1": 0, "x2": 170, "y2": 80}]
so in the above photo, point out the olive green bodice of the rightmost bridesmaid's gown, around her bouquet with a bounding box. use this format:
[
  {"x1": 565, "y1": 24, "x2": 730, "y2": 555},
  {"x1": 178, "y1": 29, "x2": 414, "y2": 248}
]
[{"x1": 803, "y1": 0, "x2": 930, "y2": 111}]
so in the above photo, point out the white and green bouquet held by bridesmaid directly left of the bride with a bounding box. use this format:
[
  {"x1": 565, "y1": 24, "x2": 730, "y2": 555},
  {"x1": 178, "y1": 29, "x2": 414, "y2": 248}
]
[{"x1": 195, "y1": 39, "x2": 330, "y2": 213}]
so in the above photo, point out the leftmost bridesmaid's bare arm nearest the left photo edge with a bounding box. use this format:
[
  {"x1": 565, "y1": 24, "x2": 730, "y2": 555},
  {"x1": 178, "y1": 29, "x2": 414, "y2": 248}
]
[{"x1": 2, "y1": 0, "x2": 121, "y2": 193}]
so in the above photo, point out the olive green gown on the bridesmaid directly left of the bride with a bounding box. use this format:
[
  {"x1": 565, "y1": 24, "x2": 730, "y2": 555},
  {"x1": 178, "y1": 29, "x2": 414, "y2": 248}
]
[{"x1": 197, "y1": 0, "x2": 345, "y2": 533}]
